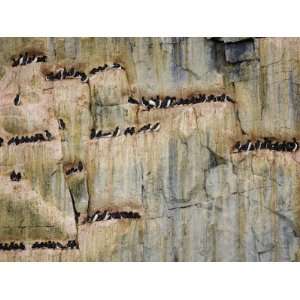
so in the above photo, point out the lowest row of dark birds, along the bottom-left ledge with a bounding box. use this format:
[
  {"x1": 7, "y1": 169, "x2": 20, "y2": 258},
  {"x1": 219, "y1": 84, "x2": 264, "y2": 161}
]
[{"x1": 0, "y1": 240, "x2": 79, "y2": 251}]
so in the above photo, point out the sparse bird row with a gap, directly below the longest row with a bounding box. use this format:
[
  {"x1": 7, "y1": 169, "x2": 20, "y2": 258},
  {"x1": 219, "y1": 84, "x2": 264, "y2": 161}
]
[{"x1": 90, "y1": 122, "x2": 160, "y2": 139}]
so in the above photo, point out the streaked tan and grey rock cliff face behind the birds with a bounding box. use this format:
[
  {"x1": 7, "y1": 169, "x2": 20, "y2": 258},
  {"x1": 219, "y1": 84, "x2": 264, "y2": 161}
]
[{"x1": 0, "y1": 38, "x2": 300, "y2": 261}]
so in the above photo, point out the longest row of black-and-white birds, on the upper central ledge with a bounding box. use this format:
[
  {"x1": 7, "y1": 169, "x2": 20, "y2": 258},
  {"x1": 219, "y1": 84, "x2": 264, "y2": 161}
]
[{"x1": 128, "y1": 94, "x2": 235, "y2": 110}]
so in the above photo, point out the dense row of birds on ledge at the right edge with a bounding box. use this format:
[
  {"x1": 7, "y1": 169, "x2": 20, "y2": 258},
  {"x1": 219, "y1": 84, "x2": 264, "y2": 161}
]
[{"x1": 233, "y1": 138, "x2": 299, "y2": 153}]
